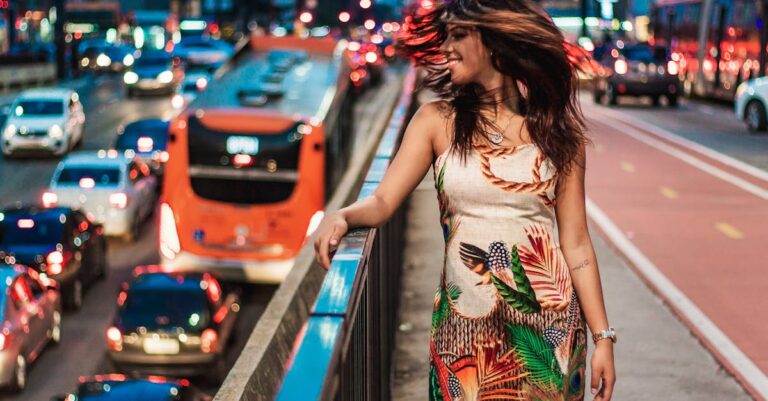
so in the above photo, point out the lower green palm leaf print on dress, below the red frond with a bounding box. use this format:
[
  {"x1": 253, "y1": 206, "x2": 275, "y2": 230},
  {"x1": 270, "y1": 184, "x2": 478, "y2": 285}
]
[{"x1": 507, "y1": 323, "x2": 563, "y2": 392}]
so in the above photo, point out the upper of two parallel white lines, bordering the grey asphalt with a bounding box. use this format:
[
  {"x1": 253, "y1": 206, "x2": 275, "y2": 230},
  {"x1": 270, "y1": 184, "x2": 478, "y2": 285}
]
[{"x1": 599, "y1": 105, "x2": 768, "y2": 182}]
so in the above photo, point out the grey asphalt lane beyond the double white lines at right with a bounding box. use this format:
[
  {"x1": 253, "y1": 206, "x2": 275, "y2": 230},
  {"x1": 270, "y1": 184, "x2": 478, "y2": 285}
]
[{"x1": 580, "y1": 92, "x2": 768, "y2": 170}]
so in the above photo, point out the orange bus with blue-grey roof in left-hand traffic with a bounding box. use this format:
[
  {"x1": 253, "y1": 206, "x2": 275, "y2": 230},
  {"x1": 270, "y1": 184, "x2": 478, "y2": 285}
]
[{"x1": 159, "y1": 37, "x2": 353, "y2": 283}]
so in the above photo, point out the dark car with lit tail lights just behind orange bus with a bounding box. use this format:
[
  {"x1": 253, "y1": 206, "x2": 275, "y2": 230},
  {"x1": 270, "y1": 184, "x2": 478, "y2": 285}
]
[{"x1": 106, "y1": 266, "x2": 240, "y2": 383}]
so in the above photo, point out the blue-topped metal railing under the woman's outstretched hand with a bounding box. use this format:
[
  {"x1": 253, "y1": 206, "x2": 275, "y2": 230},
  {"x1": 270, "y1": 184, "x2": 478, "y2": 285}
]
[{"x1": 277, "y1": 71, "x2": 415, "y2": 401}]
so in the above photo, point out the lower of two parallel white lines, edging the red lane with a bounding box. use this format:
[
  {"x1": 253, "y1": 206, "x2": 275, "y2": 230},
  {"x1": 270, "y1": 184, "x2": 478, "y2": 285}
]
[{"x1": 588, "y1": 115, "x2": 768, "y2": 200}]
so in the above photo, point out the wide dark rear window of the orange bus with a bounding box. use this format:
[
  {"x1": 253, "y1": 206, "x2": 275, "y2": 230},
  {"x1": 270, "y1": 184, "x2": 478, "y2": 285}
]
[{"x1": 188, "y1": 116, "x2": 303, "y2": 204}]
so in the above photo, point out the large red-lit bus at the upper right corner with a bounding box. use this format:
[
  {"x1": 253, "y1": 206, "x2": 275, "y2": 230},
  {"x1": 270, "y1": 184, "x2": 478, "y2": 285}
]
[{"x1": 650, "y1": 0, "x2": 768, "y2": 100}]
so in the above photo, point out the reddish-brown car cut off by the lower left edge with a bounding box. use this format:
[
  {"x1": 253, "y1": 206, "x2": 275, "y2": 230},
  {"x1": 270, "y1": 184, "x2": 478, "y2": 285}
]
[{"x1": 0, "y1": 265, "x2": 61, "y2": 391}]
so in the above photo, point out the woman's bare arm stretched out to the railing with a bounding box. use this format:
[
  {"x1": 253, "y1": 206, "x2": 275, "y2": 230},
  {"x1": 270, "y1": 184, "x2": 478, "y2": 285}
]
[{"x1": 315, "y1": 102, "x2": 445, "y2": 269}]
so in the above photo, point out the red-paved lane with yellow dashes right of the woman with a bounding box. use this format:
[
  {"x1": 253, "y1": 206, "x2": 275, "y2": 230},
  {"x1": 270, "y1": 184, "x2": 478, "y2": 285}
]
[{"x1": 587, "y1": 115, "x2": 768, "y2": 371}]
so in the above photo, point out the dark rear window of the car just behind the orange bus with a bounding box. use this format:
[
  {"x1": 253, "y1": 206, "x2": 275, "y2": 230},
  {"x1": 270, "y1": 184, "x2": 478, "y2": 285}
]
[{"x1": 119, "y1": 288, "x2": 210, "y2": 332}]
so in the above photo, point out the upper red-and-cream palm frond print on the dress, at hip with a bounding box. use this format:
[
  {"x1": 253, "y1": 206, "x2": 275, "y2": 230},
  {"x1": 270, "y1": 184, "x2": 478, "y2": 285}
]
[{"x1": 519, "y1": 224, "x2": 572, "y2": 311}]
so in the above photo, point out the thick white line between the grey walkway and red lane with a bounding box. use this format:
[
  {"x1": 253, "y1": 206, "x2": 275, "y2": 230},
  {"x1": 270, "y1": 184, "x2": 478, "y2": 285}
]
[{"x1": 586, "y1": 198, "x2": 768, "y2": 399}]
